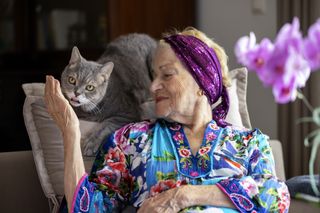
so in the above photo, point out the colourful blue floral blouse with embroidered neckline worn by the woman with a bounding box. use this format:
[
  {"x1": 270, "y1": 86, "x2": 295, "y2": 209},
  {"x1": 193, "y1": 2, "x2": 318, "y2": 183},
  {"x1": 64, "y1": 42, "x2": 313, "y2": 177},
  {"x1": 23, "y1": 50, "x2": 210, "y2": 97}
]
[{"x1": 72, "y1": 120, "x2": 290, "y2": 212}]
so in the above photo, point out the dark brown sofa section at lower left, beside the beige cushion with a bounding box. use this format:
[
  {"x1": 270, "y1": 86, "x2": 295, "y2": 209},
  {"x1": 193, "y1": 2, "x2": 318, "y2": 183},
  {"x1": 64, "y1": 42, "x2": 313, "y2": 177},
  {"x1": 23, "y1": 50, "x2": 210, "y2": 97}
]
[{"x1": 0, "y1": 151, "x2": 49, "y2": 213}]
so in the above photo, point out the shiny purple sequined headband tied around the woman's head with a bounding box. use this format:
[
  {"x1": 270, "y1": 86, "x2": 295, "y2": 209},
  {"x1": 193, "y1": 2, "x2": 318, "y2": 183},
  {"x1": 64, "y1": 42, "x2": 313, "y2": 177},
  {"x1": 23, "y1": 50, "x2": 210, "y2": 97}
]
[{"x1": 164, "y1": 35, "x2": 229, "y2": 126}]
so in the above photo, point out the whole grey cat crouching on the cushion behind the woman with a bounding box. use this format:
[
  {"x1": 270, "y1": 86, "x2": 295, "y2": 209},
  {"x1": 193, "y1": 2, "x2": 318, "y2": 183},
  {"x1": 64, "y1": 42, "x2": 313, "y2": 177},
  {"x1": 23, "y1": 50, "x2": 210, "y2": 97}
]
[{"x1": 61, "y1": 33, "x2": 157, "y2": 156}]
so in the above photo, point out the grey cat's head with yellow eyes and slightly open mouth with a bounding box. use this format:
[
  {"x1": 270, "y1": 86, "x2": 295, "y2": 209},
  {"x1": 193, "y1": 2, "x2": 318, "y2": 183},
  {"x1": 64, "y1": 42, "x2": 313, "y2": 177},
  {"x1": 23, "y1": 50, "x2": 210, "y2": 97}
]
[{"x1": 61, "y1": 48, "x2": 113, "y2": 112}]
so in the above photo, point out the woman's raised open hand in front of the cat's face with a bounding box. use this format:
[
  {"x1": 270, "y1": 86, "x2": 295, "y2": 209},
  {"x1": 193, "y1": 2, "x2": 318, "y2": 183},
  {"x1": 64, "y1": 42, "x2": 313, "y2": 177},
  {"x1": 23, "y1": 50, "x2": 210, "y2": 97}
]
[{"x1": 44, "y1": 76, "x2": 79, "y2": 134}]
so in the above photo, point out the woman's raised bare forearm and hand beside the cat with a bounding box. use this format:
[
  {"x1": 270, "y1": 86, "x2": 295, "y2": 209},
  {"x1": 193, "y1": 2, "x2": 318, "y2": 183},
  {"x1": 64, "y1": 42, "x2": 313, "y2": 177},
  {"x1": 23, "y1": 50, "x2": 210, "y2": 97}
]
[{"x1": 45, "y1": 76, "x2": 85, "y2": 212}]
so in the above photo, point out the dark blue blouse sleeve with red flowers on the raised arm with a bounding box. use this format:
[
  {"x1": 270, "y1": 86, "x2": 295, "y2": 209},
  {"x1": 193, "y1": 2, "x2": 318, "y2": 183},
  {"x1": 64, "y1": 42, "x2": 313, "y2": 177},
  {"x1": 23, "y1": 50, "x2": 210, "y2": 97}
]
[{"x1": 72, "y1": 121, "x2": 150, "y2": 213}]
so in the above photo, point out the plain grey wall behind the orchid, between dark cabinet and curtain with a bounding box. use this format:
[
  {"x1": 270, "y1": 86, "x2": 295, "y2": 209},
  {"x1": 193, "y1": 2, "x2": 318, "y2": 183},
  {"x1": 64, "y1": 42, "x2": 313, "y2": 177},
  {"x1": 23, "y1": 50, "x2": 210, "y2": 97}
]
[{"x1": 196, "y1": 0, "x2": 277, "y2": 138}]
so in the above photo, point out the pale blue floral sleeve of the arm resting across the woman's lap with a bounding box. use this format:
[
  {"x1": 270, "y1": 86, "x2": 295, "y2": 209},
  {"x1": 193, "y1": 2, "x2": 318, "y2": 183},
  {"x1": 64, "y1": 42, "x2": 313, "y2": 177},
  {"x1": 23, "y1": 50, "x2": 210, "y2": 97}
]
[{"x1": 217, "y1": 130, "x2": 290, "y2": 212}]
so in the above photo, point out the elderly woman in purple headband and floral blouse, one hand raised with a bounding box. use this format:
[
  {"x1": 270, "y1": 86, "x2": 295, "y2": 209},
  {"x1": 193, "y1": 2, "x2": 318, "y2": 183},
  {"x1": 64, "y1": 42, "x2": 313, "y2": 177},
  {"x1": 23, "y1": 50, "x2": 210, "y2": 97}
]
[{"x1": 45, "y1": 28, "x2": 289, "y2": 212}]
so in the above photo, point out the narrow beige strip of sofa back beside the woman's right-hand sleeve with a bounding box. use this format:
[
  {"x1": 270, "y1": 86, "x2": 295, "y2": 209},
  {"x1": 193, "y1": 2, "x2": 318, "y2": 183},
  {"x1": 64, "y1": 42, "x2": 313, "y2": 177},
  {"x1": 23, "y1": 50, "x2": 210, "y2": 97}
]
[{"x1": 269, "y1": 140, "x2": 286, "y2": 181}]
